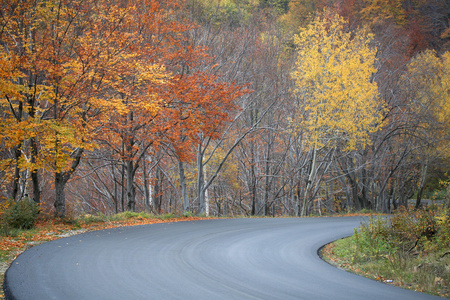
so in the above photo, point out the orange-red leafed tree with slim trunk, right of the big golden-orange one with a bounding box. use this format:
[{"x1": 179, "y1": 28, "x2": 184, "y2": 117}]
[{"x1": 96, "y1": 3, "x2": 250, "y2": 210}]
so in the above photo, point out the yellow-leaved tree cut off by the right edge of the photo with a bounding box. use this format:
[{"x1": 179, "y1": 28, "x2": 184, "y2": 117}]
[{"x1": 402, "y1": 50, "x2": 450, "y2": 208}]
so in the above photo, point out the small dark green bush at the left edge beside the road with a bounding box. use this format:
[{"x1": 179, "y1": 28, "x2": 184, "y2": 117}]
[{"x1": 1, "y1": 198, "x2": 39, "y2": 229}]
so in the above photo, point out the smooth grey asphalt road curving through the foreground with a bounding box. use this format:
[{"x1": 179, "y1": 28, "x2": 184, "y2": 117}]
[{"x1": 4, "y1": 217, "x2": 441, "y2": 300}]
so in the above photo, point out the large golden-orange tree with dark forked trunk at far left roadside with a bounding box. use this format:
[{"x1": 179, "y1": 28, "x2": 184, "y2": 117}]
[{"x1": 1, "y1": 0, "x2": 174, "y2": 217}]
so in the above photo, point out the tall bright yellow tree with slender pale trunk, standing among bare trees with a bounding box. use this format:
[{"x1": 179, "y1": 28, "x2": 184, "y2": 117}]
[{"x1": 291, "y1": 10, "x2": 382, "y2": 215}]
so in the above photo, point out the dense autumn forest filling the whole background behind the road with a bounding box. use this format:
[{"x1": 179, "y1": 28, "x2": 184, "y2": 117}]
[{"x1": 0, "y1": 0, "x2": 450, "y2": 217}]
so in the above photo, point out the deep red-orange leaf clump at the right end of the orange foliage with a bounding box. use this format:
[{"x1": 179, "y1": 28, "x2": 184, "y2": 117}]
[{"x1": 162, "y1": 67, "x2": 248, "y2": 160}]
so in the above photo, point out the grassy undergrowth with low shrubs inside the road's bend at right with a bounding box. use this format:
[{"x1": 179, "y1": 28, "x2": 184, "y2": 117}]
[{"x1": 324, "y1": 206, "x2": 450, "y2": 297}]
